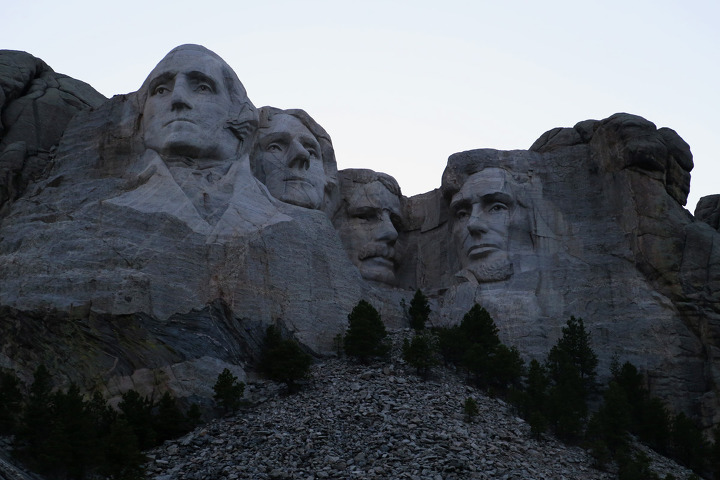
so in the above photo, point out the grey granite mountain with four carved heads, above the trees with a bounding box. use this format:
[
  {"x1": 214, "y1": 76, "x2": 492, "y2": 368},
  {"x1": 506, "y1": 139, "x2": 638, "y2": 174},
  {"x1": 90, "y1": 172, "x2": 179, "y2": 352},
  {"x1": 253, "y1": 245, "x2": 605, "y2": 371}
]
[{"x1": 0, "y1": 45, "x2": 720, "y2": 426}]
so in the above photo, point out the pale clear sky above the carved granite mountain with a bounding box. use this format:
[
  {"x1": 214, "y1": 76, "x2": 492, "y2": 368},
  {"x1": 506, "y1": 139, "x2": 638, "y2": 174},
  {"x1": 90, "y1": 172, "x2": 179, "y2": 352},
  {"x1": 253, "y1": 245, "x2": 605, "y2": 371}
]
[{"x1": 0, "y1": 0, "x2": 720, "y2": 212}]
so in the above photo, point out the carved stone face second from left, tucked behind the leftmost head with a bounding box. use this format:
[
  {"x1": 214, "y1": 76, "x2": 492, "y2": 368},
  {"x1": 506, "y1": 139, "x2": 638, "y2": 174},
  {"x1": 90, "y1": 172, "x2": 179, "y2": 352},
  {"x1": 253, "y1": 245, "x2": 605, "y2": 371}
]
[{"x1": 257, "y1": 114, "x2": 327, "y2": 210}]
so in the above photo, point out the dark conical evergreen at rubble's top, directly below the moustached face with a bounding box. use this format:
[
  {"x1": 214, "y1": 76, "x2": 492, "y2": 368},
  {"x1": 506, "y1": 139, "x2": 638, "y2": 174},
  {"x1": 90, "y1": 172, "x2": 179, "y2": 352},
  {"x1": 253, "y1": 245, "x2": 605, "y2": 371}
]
[{"x1": 345, "y1": 300, "x2": 390, "y2": 364}]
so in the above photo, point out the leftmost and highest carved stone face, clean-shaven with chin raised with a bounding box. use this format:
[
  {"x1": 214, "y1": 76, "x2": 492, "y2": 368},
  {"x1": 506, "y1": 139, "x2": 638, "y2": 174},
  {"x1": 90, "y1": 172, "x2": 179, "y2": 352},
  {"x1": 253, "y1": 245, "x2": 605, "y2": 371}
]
[{"x1": 142, "y1": 49, "x2": 239, "y2": 160}]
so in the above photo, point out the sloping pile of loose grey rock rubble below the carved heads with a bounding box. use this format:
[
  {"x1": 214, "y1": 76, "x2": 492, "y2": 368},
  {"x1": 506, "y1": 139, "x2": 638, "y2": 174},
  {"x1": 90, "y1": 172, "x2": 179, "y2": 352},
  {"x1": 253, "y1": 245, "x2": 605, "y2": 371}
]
[{"x1": 147, "y1": 332, "x2": 691, "y2": 480}]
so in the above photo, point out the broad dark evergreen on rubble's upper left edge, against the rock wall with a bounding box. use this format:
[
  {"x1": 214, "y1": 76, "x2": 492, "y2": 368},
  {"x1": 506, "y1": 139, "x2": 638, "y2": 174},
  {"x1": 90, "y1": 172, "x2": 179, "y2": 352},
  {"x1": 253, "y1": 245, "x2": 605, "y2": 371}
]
[{"x1": 260, "y1": 325, "x2": 312, "y2": 393}]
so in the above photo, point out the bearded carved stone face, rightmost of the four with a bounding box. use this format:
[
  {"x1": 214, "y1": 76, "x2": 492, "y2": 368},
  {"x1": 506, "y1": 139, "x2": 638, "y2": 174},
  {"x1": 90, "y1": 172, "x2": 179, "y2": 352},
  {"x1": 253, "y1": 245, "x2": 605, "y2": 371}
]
[{"x1": 450, "y1": 168, "x2": 515, "y2": 282}]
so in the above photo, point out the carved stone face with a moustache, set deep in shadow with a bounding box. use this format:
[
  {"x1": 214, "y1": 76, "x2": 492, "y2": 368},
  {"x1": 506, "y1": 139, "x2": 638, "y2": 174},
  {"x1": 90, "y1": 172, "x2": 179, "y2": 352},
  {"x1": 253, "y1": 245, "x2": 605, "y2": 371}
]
[{"x1": 336, "y1": 181, "x2": 402, "y2": 284}]
